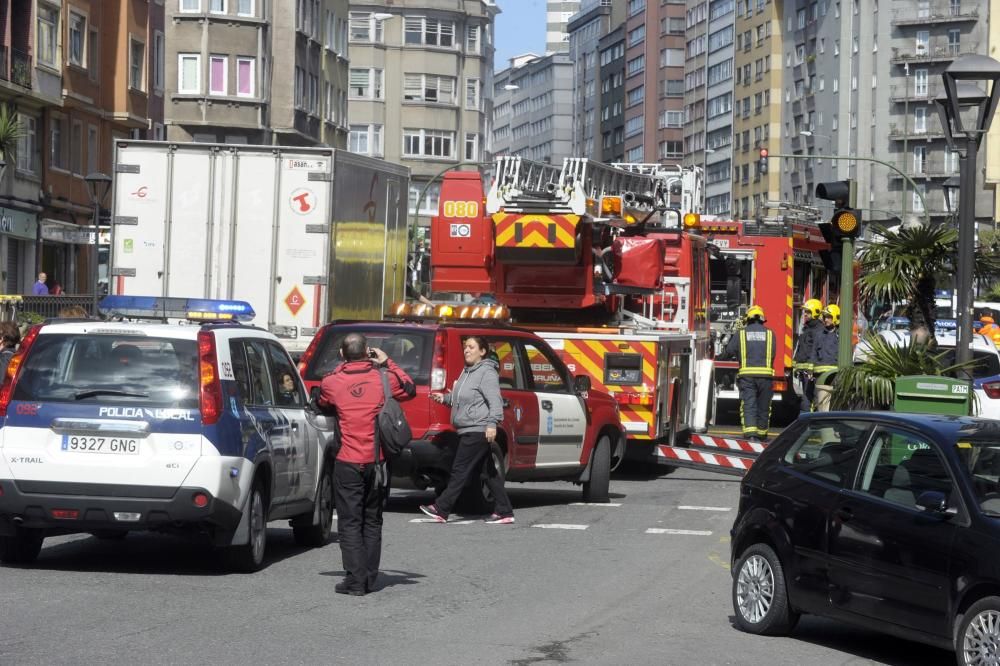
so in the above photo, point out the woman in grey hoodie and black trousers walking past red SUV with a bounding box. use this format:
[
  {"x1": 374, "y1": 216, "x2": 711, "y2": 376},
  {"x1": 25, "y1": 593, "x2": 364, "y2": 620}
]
[{"x1": 420, "y1": 335, "x2": 514, "y2": 525}]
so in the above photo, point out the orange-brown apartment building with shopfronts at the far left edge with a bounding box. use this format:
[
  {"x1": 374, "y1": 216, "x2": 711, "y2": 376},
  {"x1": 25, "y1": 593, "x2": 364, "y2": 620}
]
[{"x1": 0, "y1": 0, "x2": 164, "y2": 293}]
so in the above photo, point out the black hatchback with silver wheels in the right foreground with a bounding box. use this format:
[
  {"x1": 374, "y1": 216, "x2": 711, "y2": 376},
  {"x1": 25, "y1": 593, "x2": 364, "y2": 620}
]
[{"x1": 732, "y1": 412, "x2": 1000, "y2": 664}]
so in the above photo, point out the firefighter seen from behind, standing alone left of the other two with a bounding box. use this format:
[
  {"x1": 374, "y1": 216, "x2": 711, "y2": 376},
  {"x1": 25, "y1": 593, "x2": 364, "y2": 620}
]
[{"x1": 726, "y1": 305, "x2": 777, "y2": 442}]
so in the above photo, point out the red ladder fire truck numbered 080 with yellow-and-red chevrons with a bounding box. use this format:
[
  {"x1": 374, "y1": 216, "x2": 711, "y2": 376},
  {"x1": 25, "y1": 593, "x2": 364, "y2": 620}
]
[{"x1": 431, "y1": 156, "x2": 713, "y2": 461}]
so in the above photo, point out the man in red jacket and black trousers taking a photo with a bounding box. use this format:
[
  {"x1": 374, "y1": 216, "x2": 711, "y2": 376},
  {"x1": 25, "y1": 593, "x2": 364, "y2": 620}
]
[{"x1": 316, "y1": 333, "x2": 416, "y2": 596}]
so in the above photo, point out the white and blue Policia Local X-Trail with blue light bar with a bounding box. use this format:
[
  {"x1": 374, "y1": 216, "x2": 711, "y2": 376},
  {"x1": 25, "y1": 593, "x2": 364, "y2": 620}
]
[{"x1": 0, "y1": 296, "x2": 333, "y2": 571}]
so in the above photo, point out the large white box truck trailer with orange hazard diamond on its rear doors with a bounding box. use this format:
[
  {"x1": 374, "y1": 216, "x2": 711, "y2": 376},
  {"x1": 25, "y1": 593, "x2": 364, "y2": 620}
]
[{"x1": 109, "y1": 140, "x2": 409, "y2": 353}]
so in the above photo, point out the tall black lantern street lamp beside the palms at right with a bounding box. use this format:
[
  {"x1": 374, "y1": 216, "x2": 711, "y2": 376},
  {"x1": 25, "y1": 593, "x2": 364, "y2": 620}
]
[{"x1": 935, "y1": 55, "x2": 1000, "y2": 363}]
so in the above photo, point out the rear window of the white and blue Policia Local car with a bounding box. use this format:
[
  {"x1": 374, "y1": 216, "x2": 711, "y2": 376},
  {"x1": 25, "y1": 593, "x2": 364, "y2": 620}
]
[{"x1": 13, "y1": 334, "x2": 198, "y2": 409}]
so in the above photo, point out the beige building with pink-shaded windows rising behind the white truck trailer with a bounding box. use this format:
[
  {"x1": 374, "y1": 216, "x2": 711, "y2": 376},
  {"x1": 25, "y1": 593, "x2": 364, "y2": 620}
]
[{"x1": 166, "y1": 0, "x2": 348, "y2": 148}]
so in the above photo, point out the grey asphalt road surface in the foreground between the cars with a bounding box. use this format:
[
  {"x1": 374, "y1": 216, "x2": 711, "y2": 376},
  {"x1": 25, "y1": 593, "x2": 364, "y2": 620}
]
[{"x1": 0, "y1": 470, "x2": 954, "y2": 666}]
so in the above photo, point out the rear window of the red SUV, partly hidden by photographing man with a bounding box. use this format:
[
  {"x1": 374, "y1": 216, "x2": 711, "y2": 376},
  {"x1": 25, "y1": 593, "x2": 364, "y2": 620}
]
[{"x1": 303, "y1": 325, "x2": 434, "y2": 385}]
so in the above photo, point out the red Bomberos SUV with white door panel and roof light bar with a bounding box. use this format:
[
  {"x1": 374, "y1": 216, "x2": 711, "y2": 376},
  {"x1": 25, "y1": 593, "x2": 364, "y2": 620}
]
[{"x1": 299, "y1": 321, "x2": 625, "y2": 506}]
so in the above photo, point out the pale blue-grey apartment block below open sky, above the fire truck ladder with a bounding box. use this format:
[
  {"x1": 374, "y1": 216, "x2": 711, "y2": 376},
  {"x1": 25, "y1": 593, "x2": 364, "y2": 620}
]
[{"x1": 493, "y1": 53, "x2": 575, "y2": 164}]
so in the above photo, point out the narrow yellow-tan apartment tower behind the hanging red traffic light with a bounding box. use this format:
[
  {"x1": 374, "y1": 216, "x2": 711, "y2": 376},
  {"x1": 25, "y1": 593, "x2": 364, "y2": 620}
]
[{"x1": 732, "y1": 0, "x2": 791, "y2": 218}]
